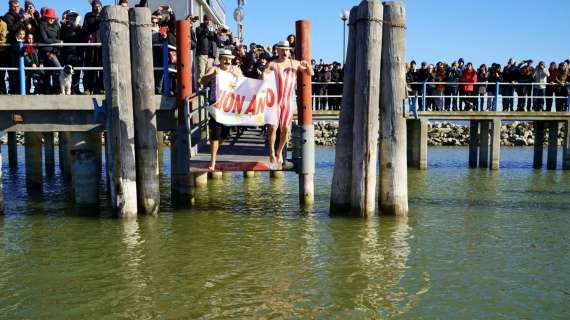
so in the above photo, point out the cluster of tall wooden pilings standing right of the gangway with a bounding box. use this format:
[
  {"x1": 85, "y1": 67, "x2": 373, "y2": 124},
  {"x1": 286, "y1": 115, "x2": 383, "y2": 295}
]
[{"x1": 331, "y1": 0, "x2": 408, "y2": 216}]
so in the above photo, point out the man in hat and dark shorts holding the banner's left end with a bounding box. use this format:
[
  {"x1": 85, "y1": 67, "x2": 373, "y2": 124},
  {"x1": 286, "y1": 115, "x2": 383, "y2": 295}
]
[{"x1": 200, "y1": 49, "x2": 242, "y2": 171}]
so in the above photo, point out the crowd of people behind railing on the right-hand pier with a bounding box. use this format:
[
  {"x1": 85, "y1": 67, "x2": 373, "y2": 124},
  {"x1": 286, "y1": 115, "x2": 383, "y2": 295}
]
[{"x1": 406, "y1": 58, "x2": 570, "y2": 111}]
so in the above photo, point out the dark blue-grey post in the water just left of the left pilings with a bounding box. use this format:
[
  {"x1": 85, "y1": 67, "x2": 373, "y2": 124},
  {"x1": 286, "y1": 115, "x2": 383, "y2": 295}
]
[{"x1": 71, "y1": 132, "x2": 99, "y2": 208}]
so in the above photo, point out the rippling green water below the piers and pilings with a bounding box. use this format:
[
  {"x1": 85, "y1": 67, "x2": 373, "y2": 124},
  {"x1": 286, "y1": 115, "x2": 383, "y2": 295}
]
[{"x1": 0, "y1": 148, "x2": 570, "y2": 319}]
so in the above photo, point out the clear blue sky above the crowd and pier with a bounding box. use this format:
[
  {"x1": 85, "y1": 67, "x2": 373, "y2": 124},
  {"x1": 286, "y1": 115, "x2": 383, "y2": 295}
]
[{"x1": 13, "y1": 0, "x2": 570, "y2": 64}]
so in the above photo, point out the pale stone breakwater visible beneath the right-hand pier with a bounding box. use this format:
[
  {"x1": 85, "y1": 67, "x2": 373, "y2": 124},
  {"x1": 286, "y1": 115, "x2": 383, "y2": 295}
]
[{"x1": 315, "y1": 121, "x2": 564, "y2": 147}]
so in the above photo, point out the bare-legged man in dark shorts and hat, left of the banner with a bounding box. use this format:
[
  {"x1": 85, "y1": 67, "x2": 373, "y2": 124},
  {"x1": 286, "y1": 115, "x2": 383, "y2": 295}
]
[{"x1": 200, "y1": 49, "x2": 242, "y2": 171}]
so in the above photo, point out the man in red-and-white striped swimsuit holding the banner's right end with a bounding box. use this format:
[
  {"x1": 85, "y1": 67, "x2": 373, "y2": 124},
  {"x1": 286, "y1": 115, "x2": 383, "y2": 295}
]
[{"x1": 264, "y1": 41, "x2": 314, "y2": 166}]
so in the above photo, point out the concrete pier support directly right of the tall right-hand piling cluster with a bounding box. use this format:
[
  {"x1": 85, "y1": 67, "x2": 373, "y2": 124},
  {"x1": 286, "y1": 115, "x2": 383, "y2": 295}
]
[{"x1": 407, "y1": 119, "x2": 428, "y2": 170}]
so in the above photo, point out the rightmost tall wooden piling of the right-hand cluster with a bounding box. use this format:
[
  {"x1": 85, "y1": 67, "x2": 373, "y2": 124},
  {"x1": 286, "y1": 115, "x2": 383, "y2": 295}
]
[{"x1": 378, "y1": 1, "x2": 408, "y2": 216}]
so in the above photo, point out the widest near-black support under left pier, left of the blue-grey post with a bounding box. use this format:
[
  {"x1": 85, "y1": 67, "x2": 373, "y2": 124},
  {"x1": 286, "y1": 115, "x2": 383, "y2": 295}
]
[{"x1": 24, "y1": 132, "x2": 43, "y2": 189}]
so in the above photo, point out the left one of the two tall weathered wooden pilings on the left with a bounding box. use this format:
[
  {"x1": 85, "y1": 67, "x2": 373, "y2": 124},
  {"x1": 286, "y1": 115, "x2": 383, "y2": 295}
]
[{"x1": 101, "y1": 6, "x2": 137, "y2": 218}]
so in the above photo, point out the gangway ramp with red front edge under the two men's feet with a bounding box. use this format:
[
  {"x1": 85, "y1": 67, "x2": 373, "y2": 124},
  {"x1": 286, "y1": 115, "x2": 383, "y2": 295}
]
[{"x1": 190, "y1": 129, "x2": 293, "y2": 173}]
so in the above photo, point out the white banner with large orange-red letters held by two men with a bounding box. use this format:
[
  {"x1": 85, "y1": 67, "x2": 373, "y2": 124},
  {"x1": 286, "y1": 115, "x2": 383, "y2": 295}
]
[{"x1": 209, "y1": 70, "x2": 279, "y2": 126}]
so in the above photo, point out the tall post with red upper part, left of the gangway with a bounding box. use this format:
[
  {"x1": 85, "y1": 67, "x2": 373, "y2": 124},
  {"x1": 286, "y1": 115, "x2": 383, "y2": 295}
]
[{"x1": 170, "y1": 20, "x2": 194, "y2": 206}]
